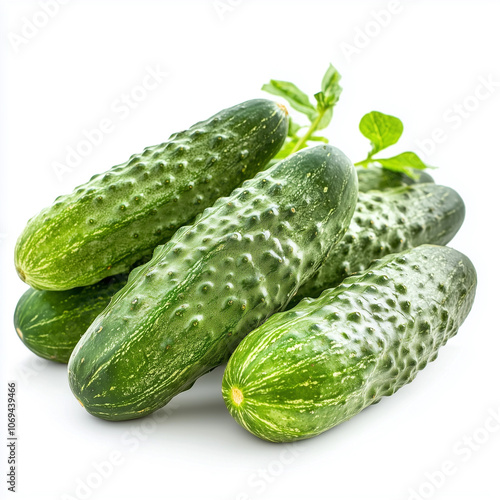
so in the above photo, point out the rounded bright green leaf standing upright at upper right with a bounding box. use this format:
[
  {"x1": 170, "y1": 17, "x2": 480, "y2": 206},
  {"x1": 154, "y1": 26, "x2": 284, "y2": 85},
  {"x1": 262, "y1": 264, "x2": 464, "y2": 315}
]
[{"x1": 359, "y1": 111, "x2": 403, "y2": 156}]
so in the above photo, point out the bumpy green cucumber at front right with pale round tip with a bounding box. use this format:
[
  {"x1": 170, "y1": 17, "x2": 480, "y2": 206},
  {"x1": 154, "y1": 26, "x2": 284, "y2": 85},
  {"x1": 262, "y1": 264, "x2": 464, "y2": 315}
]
[{"x1": 222, "y1": 245, "x2": 477, "y2": 442}]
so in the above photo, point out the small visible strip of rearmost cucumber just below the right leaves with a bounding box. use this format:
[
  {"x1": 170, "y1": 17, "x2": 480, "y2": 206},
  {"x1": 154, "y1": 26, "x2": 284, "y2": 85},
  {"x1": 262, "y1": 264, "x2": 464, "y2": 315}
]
[{"x1": 356, "y1": 166, "x2": 434, "y2": 193}]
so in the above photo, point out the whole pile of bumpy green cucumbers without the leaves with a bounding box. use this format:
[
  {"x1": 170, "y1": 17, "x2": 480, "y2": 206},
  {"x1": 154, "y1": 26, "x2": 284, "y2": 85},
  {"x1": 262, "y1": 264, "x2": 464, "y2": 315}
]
[{"x1": 14, "y1": 99, "x2": 477, "y2": 442}]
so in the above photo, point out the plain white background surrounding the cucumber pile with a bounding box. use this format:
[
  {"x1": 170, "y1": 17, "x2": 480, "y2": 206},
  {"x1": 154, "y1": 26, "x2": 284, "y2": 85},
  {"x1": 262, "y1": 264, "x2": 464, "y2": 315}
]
[{"x1": 0, "y1": 0, "x2": 500, "y2": 500}]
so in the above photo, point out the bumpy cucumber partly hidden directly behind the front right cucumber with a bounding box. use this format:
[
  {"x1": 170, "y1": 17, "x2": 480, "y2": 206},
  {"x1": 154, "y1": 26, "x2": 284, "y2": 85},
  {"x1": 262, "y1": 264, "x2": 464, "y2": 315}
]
[{"x1": 289, "y1": 184, "x2": 465, "y2": 308}]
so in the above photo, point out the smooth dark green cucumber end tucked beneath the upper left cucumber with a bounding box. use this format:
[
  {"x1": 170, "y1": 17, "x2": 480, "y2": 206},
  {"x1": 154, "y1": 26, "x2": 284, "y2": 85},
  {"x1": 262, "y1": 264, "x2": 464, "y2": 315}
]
[{"x1": 14, "y1": 274, "x2": 128, "y2": 363}]
